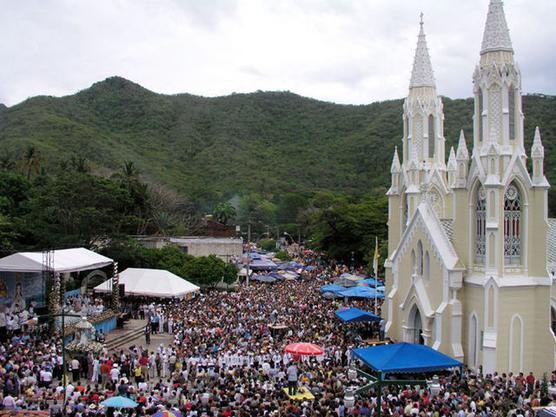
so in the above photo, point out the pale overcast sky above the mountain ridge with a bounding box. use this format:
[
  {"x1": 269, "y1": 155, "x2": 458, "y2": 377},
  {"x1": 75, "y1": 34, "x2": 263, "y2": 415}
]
[{"x1": 0, "y1": 0, "x2": 556, "y2": 106}]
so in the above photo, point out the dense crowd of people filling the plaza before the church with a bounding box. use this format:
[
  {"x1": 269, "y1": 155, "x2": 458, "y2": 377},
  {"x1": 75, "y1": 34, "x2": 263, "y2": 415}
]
[{"x1": 0, "y1": 254, "x2": 556, "y2": 417}]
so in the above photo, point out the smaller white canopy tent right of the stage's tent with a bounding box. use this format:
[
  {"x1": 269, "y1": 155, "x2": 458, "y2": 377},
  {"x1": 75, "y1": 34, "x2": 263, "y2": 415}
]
[{"x1": 95, "y1": 268, "x2": 199, "y2": 298}]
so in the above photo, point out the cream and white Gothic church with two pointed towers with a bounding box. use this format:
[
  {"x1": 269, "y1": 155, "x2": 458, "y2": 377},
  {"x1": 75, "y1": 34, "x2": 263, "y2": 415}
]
[{"x1": 383, "y1": 0, "x2": 556, "y2": 376}]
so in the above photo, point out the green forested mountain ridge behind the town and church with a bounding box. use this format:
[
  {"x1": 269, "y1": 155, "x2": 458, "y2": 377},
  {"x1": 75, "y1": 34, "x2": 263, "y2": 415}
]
[{"x1": 0, "y1": 77, "x2": 556, "y2": 206}]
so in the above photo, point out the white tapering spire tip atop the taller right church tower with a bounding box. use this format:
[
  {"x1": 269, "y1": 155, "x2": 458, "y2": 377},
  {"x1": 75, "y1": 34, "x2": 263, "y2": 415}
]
[{"x1": 481, "y1": 0, "x2": 514, "y2": 55}]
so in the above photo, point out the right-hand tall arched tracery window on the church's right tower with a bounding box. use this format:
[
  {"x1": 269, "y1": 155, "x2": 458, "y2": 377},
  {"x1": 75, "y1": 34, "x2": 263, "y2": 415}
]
[{"x1": 504, "y1": 184, "x2": 521, "y2": 265}]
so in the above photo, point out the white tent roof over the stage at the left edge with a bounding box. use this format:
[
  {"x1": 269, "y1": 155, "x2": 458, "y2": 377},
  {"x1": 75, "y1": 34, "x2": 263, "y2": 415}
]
[{"x1": 0, "y1": 248, "x2": 114, "y2": 273}]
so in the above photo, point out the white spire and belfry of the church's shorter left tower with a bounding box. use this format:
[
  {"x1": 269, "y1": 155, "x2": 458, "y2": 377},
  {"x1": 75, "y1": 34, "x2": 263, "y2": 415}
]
[{"x1": 403, "y1": 13, "x2": 446, "y2": 171}]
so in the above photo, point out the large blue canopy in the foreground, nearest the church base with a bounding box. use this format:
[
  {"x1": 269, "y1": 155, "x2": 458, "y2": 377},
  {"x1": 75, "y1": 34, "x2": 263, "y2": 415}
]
[{"x1": 351, "y1": 343, "x2": 463, "y2": 373}]
